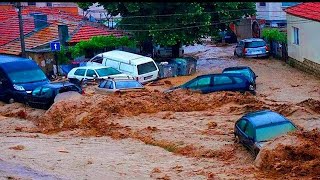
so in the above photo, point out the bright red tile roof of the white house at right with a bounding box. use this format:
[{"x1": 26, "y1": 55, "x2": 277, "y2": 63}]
[{"x1": 285, "y1": 2, "x2": 320, "y2": 22}]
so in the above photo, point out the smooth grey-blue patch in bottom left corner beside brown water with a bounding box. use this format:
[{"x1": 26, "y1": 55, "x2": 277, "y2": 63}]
[{"x1": 0, "y1": 160, "x2": 62, "y2": 180}]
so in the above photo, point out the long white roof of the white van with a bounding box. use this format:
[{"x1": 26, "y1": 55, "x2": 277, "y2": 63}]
[{"x1": 98, "y1": 50, "x2": 153, "y2": 65}]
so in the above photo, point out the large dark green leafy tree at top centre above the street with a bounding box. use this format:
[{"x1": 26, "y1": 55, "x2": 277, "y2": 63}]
[{"x1": 77, "y1": 2, "x2": 255, "y2": 56}]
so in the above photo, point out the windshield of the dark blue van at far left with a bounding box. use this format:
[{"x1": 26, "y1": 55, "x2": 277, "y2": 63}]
[{"x1": 8, "y1": 69, "x2": 47, "y2": 84}]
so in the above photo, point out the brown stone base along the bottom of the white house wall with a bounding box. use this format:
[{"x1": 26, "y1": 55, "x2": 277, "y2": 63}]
[{"x1": 288, "y1": 57, "x2": 320, "y2": 77}]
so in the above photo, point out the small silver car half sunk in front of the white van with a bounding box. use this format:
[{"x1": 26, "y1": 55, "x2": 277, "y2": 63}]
[{"x1": 96, "y1": 77, "x2": 144, "y2": 93}]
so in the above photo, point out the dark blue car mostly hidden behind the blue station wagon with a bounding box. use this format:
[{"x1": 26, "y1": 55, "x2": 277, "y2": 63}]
[{"x1": 222, "y1": 66, "x2": 258, "y2": 89}]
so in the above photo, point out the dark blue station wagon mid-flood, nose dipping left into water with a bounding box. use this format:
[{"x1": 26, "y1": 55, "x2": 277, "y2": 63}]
[{"x1": 165, "y1": 73, "x2": 255, "y2": 94}]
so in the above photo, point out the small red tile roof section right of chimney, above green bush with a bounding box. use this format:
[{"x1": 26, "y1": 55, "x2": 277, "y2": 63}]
[{"x1": 69, "y1": 25, "x2": 123, "y2": 43}]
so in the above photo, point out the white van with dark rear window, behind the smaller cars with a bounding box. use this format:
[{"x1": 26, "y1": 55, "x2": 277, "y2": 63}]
[{"x1": 87, "y1": 50, "x2": 159, "y2": 83}]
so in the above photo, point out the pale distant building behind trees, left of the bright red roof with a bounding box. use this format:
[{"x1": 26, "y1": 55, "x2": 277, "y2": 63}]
[{"x1": 256, "y1": 2, "x2": 298, "y2": 27}]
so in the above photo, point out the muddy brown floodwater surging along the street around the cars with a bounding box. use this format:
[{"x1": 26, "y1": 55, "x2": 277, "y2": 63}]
[{"x1": 0, "y1": 43, "x2": 320, "y2": 179}]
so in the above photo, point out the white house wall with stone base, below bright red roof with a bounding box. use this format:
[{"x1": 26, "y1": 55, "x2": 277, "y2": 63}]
[{"x1": 287, "y1": 14, "x2": 320, "y2": 76}]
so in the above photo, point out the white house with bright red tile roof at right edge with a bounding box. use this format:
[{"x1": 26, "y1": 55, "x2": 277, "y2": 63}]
[{"x1": 286, "y1": 2, "x2": 320, "y2": 77}]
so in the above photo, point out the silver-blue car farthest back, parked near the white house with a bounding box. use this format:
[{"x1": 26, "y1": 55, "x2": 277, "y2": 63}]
[{"x1": 234, "y1": 38, "x2": 269, "y2": 57}]
